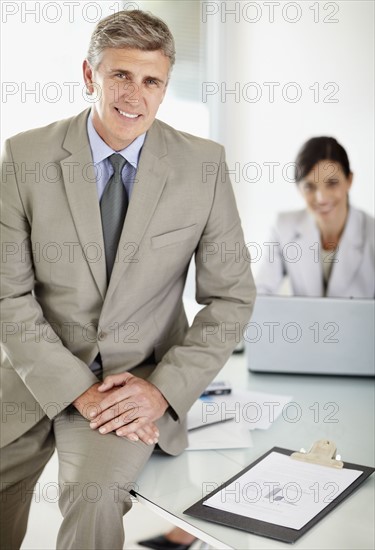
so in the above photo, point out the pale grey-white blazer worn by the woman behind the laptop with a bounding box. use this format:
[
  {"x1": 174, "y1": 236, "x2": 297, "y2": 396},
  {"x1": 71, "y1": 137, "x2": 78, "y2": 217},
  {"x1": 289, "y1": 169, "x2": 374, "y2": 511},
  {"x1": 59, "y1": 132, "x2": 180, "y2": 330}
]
[{"x1": 256, "y1": 207, "x2": 375, "y2": 298}]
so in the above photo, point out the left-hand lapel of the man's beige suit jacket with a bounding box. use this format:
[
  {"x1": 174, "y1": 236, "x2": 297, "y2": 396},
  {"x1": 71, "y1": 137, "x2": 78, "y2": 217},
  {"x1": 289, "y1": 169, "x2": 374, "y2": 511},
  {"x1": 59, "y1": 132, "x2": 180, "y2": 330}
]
[{"x1": 60, "y1": 110, "x2": 107, "y2": 298}]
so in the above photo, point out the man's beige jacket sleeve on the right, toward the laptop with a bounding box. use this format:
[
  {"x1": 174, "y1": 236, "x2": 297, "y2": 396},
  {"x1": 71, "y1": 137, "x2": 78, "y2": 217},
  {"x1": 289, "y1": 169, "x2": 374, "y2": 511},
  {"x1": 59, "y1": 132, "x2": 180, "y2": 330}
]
[{"x1": 149, "y1": 149, "x2": 256, "y2": 418}]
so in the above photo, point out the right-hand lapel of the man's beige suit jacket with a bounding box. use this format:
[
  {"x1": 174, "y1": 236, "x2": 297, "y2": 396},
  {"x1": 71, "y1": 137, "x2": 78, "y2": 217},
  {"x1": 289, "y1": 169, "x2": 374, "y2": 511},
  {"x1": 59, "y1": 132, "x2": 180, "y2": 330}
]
[{"x1": 106, "y1": 121, "x2": 169, "y2": 304}]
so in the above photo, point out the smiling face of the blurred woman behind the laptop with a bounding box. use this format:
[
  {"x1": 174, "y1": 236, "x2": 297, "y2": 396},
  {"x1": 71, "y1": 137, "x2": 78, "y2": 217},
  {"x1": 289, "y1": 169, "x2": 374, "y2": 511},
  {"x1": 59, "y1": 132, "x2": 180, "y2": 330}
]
[{"x1": 298, "y1": 160, "x2": 353, "y2": 227}]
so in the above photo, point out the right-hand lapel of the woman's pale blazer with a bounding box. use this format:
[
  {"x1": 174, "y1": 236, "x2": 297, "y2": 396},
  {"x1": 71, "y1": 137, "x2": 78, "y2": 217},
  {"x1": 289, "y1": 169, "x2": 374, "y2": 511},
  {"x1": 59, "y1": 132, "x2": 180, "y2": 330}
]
[{"x1": 327, "y1": 208, "x2": 365, "y2": 296}]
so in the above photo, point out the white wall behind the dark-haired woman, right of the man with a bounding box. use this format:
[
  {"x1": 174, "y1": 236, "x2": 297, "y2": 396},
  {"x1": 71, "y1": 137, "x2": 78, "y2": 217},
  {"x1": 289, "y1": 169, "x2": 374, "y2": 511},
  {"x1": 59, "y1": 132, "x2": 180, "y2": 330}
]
[{"x1": 203, "y1": 1, "x2": 374, "y2": 270}]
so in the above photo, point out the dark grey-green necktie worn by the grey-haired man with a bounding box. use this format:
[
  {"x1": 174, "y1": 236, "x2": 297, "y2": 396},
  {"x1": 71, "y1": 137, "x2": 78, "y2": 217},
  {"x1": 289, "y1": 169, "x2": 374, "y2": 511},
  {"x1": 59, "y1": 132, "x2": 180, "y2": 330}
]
[{"x1": 100, "y1": 153, "x2": 128, "y2": 281}]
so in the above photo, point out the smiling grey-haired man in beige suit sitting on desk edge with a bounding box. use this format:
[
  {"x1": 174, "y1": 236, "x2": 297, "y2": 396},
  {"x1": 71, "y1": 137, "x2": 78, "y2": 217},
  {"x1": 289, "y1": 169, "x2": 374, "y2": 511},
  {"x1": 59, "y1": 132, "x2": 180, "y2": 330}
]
[{"x1": 1, "y1": 10, "x2": 255, "y2": 550}]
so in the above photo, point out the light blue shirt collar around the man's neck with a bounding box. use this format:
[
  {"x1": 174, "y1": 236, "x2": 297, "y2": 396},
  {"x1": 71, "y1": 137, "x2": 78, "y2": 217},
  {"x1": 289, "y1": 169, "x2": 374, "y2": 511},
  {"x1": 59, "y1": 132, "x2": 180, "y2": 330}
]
[{"x1": 87, "y1": 113, "x2": 146, "y2": 169}]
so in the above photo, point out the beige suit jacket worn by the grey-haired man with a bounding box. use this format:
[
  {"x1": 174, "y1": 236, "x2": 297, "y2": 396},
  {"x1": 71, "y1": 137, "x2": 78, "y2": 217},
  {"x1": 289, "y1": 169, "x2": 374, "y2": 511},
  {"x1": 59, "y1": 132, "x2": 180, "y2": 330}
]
[{"x1": 1, "y1": 111, "x2": 255, "y2": 454}]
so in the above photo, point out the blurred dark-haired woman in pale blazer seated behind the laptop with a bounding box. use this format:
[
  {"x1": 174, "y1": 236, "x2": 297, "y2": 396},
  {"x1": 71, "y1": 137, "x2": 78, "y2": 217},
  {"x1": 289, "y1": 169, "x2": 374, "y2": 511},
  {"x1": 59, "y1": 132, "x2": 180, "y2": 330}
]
[{"x1": 256, "y1": 137, "x2": 375, "y2": 298}]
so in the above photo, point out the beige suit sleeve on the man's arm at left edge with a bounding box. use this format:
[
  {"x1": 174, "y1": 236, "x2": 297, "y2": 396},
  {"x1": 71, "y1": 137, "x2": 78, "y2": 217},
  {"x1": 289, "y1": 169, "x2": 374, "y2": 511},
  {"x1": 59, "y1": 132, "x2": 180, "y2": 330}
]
[{"x1": 0, "y1": 141, "x2": 98, "y2": 418}]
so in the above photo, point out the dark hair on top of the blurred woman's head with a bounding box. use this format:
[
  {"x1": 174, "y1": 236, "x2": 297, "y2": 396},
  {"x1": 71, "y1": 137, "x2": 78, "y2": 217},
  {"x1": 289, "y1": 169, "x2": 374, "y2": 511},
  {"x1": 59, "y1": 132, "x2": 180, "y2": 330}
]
[{"x1": 295, "y1": 136, "x2": 351, "y2": 183}]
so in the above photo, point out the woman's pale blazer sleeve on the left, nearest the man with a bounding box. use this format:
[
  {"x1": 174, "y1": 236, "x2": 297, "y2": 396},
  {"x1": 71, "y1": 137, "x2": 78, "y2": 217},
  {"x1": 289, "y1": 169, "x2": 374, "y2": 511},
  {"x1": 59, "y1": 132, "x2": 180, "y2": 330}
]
[{"x1": 255, "y1": 222, "x2": 286, "y2": 294}]
